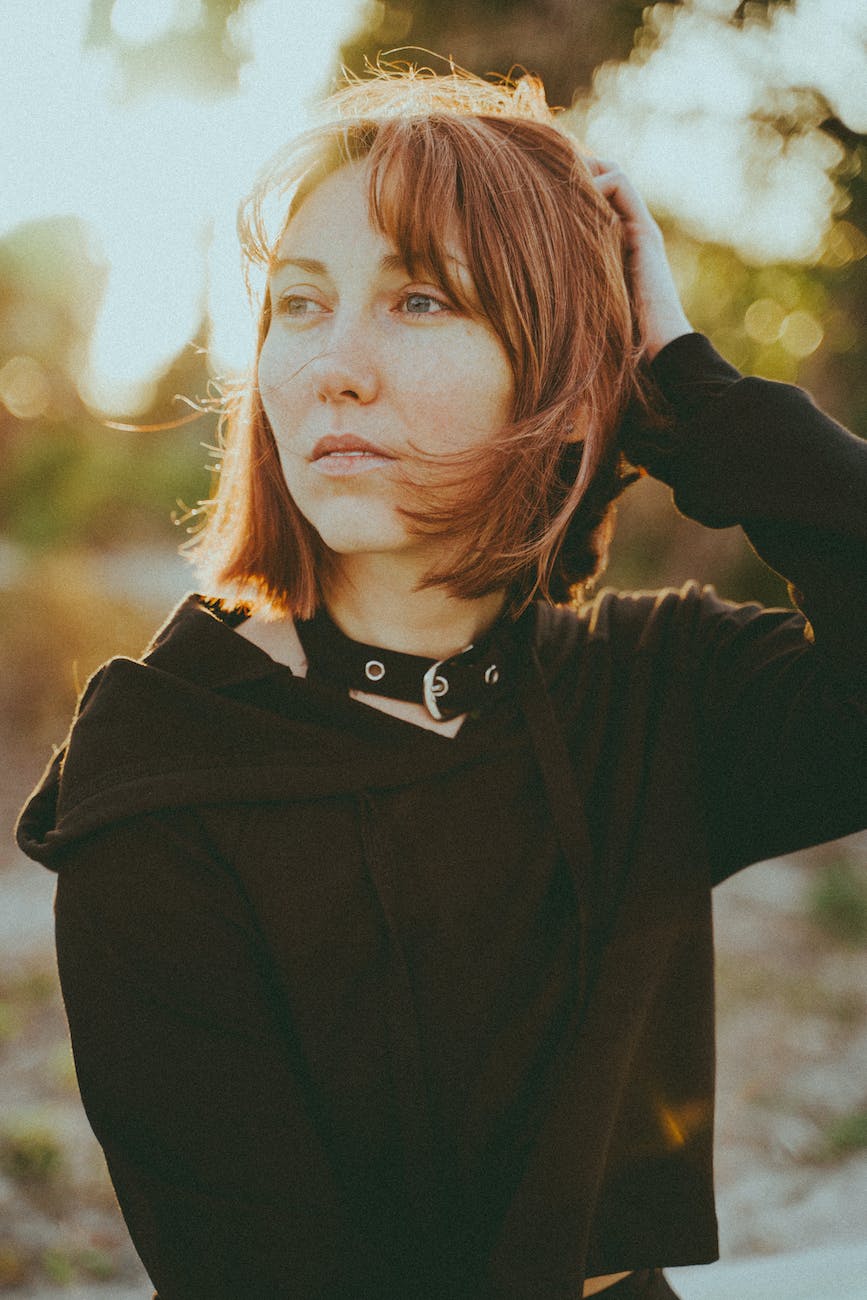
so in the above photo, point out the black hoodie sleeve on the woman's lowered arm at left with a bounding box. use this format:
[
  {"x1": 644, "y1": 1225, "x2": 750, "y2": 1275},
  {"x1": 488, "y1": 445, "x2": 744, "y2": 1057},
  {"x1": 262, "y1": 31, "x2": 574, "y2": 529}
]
[{"x1": 55, "y1": 813, "x2": 339, "y2": 1300}]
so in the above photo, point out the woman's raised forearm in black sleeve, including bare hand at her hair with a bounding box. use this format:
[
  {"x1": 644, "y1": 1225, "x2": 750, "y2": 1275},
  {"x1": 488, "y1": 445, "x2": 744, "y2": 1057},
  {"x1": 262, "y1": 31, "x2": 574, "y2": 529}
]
[{"x1": 585, "y1": 157, "x2": 867, "y2": 680}]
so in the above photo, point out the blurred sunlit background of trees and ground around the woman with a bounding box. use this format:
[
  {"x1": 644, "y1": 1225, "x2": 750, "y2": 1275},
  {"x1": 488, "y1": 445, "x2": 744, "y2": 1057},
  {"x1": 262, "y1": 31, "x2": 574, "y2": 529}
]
[{"x1": 0, "y1": 0, "x2": 867, "y2": 1296}]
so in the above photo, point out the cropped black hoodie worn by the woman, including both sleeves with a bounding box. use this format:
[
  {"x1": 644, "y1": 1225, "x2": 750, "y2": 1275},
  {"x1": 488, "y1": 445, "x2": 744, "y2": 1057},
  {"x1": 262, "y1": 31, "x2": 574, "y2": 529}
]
[{"x1": 18, "y1": 334, "x2": 867, "y2": 1300}]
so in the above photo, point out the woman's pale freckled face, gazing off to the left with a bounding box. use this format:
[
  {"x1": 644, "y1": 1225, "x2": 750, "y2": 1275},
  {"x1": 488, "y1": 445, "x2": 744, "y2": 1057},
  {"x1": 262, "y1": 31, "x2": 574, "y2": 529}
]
[{"x1": 259, "y1": 164, "x2": 513, "y2": 556}]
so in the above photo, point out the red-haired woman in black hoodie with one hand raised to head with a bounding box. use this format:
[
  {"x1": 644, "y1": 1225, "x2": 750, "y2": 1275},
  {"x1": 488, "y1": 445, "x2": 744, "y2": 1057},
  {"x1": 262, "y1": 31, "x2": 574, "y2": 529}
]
[{"x1": 18, "y1": 65, "x2": 867, "y2": 1300}]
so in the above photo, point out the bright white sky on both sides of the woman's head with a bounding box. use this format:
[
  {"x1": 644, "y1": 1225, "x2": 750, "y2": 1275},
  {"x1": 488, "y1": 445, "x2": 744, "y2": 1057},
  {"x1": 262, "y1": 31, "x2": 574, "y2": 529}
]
[{"x1": 0, "y1": 0, "x2": 867, "y2": 415}]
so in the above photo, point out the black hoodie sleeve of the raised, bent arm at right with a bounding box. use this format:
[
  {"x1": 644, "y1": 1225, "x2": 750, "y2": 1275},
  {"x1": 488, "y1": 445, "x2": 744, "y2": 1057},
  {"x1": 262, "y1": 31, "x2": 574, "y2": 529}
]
[{"x1": 623, "y1": 334, "x2": 867, "y2": 879}]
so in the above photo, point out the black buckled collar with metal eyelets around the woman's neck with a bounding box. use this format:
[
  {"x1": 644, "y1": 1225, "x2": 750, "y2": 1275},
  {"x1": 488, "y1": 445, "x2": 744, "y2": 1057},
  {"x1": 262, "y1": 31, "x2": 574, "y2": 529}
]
[{"x1": 295, "y1": 606, "x2": 529, "y2": 722}]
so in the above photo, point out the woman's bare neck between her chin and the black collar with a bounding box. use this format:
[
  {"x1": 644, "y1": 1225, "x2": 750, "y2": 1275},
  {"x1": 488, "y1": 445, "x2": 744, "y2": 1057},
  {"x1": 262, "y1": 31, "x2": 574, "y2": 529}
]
[{"x1": 326, "y1": 555, "x2": 506, "y2": 659}]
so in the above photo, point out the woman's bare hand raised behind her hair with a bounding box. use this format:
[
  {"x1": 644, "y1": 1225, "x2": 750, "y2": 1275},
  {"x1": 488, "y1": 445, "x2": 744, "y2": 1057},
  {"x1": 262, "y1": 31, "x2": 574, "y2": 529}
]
[{"x1": 582, "y1": 155, "x2": 693, "y2": 361}]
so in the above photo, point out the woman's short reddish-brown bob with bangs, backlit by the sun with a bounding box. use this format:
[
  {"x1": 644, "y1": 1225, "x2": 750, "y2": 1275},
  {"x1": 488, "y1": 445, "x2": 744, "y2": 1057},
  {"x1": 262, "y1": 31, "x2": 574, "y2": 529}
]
[{"x1": 187, "y1": 68, "x2": 654, "y2": 619}]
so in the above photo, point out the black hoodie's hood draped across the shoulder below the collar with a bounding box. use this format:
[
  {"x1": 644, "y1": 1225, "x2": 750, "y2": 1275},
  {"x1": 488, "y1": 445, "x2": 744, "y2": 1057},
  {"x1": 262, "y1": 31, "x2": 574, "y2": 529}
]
[{"x1": 16, "y1": 593, "x2": 587, "y2": 870}]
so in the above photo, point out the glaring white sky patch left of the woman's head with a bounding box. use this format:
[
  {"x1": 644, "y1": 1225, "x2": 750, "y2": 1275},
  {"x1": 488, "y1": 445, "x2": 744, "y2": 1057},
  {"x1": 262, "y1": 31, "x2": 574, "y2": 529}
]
[{"x1": 0, "y1": 0, "x2": 368, "y2": 413}]
